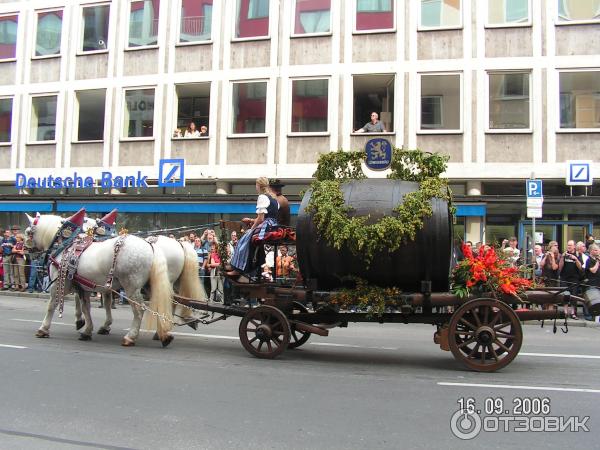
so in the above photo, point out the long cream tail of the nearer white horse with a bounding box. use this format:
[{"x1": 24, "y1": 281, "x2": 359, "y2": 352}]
[{"x1": 150, "y1": 246, "x2": 173, "y2": 341}]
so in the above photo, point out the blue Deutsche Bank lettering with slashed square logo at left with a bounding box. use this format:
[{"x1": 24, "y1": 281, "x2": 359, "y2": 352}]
[{"x1": 15, "y1": 159, "x2": 185, "y2": 189}]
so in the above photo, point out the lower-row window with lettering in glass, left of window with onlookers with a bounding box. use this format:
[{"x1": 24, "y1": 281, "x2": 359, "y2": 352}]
[{"x1": 123, "y1": 88, "x2": 154, "y2": 138}]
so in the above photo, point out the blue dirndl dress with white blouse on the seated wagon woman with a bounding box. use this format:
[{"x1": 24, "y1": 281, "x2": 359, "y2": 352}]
[{"x1": 230, "y1": 194, "x2": 279, "y2": 273}]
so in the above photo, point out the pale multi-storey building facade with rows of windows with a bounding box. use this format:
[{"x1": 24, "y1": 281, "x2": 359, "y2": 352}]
[{"x1": 0, "y1": 0, "x2": 600, "y2": 246}]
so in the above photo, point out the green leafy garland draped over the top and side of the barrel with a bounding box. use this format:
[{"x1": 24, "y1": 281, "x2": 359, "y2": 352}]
[{"x1": 306, "y1": 148, "x2": 451, "y2": 265}]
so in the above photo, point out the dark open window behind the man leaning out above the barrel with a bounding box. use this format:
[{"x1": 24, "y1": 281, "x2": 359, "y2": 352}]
[{"x1": 353, "y1": 74, "x2": 395, "y2": 131}]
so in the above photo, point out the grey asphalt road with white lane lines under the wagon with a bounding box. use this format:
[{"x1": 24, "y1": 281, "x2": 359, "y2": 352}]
[{"x1": 0, "y1": 297, "x2": 600, "y2": 450}]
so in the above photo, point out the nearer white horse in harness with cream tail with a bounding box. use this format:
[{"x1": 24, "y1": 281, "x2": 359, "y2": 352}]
[{"x1": 27, "y1": 215, "x2": 173, "y2": 346}]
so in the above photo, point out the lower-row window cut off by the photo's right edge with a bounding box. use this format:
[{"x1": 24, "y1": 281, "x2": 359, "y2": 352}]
[{"x1": 559, "y1": 71, "x2": 600, "y2": 128}]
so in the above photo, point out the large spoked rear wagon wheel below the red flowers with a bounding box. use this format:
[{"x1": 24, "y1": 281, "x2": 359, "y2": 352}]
[{"x1": 448, "y1": 298, "x2": 523, "y2": 372}]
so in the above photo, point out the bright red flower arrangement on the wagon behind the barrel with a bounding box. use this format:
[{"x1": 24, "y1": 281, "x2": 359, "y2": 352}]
[{"x1": 451, "y1": 245, "x2": 531, "y2": 298}]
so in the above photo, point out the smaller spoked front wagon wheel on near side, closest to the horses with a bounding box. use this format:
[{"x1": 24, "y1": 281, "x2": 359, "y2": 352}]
[{"x1": 239, "y1": 305, "x2": 290, "y2": 359}]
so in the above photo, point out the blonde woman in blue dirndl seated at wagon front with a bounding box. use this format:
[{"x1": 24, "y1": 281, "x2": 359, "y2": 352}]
[{"x1": 227, "y1": 177, "x2": 279, "y2": 277}]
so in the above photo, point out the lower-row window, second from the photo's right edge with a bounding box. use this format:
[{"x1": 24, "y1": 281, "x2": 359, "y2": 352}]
[{"x1": 489, "y1": 72, "x2": 530, "y2": 130}]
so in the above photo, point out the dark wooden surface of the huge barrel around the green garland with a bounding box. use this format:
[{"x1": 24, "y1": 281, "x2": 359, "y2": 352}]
[{"x1": 296, "y1": 179, "x2": 452, "y2": 292}]
